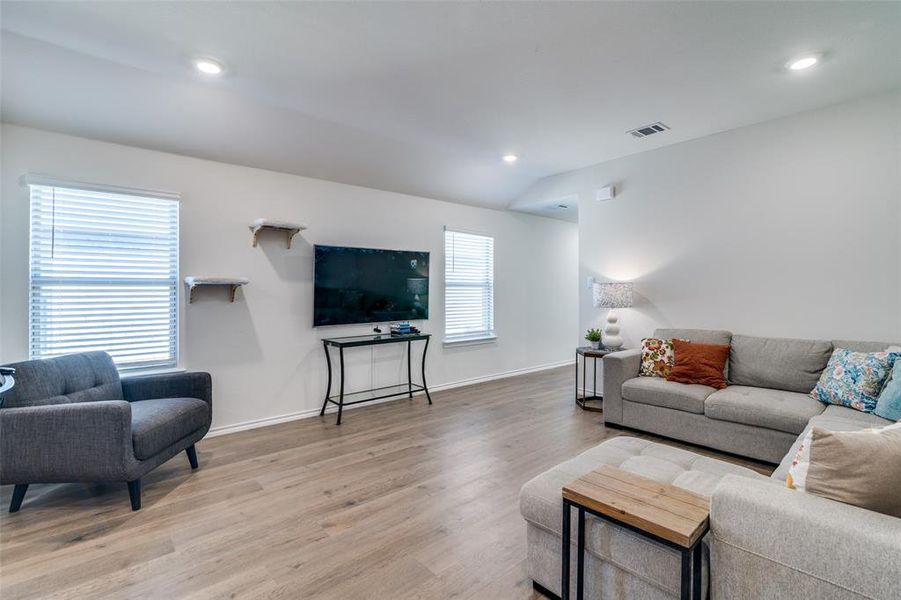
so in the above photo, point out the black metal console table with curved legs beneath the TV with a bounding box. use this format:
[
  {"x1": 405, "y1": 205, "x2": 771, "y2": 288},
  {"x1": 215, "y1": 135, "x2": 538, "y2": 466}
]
[{"x1": 319, "y1": 333, "x2": 432, "y2": 425}]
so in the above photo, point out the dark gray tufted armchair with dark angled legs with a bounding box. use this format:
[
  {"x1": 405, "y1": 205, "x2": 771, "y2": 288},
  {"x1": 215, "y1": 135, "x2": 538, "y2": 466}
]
[{"x1": 0, "y1": 352, "x2": 212, "y2": 512}]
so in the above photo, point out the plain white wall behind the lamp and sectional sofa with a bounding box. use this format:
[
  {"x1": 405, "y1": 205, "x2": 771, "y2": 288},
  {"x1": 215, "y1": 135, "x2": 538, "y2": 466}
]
[{"x1": 518, "y1": 93, "x2": 901, "y2": 347}]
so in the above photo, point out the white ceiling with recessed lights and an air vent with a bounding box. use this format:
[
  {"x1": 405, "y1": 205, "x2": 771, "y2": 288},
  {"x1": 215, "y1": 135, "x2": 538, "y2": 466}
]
[{"x1": 0, "y1": 0, "x2": 901, "y2": 218}]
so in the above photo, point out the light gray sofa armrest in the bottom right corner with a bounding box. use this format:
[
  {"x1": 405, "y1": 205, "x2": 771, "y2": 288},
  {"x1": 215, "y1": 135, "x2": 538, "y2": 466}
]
[{"x1": 710, "y1": 475, "x2": 901, "y2": 599}]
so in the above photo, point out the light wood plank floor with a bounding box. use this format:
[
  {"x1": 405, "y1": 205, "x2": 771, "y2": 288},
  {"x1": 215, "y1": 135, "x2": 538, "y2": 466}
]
[{"x1": 0, "y1": 368, "x2": 770, "y2": 600}]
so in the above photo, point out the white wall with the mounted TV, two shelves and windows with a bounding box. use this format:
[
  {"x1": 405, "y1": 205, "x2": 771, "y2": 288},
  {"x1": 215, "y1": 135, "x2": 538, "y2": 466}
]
[{"x1": 0, "y1": 125, "x2": 578, "y2": 428}]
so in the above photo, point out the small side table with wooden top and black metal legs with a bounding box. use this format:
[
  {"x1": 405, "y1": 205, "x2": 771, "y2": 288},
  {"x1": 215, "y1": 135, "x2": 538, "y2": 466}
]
[{"x1": 561, "y1": 465, "x2": 710, "y2": 600}]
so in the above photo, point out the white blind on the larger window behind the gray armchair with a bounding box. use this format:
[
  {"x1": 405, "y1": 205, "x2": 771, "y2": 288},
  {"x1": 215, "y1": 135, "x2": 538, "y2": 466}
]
[{"x1": 29, "y1": 184, "x2": 178, "y2": 370}]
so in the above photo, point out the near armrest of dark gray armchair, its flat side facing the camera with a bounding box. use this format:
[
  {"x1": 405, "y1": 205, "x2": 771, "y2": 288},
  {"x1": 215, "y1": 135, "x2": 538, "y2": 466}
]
[{"x1": 0, "y1": 400, "x2": 135, "y2": 483}]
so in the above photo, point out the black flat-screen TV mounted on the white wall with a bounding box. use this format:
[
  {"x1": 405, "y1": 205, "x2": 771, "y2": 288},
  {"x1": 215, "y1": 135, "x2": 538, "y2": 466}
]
[{"x1": 313, "y1": 245, "x2": 429, "y2": 327}]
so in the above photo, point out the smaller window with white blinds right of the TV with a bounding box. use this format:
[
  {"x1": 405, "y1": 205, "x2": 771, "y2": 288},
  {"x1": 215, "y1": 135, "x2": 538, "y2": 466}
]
[{"x1": 444, "y1": 229, "x2": 494, "y2": 343}]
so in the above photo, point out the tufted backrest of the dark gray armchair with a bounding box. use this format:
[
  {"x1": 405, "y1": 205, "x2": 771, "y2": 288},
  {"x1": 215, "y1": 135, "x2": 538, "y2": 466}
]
[{"x1": 3, "y1": 352, "x2": 123, "y2": 408}]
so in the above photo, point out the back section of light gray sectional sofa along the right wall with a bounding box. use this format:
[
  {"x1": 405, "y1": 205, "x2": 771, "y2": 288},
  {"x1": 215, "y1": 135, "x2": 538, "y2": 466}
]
[{"x1": 604, "y1": 329, "x2": 889, "y2": 463}]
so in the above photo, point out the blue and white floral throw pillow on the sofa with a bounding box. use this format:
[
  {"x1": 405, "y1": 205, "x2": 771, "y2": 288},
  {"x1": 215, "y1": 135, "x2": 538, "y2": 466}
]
[{"x1": 810, "y1": 348, "x2": 901, "y2": 413}]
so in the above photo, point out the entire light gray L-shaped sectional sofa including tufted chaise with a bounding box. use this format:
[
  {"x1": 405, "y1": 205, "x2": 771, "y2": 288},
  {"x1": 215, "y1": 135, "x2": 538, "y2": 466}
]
[{"x1": 520, "y1": 329, "x2": 901, "y2": 600}]
